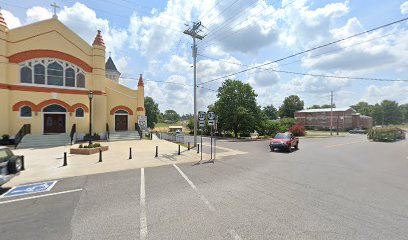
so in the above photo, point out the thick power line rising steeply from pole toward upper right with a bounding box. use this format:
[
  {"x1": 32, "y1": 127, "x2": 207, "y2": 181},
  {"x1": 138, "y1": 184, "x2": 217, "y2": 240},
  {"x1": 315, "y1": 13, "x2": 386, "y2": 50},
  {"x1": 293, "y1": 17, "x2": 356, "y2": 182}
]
[{"x1": 201, "y1": 17, "x2": 408, "y2": 85}]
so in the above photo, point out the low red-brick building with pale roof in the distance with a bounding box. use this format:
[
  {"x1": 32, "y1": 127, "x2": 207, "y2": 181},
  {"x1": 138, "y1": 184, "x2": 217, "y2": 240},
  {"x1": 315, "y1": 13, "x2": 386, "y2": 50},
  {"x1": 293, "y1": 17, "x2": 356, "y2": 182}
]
[{"x1": 295, "y1": 107, "x2": 373, "y2": 131}]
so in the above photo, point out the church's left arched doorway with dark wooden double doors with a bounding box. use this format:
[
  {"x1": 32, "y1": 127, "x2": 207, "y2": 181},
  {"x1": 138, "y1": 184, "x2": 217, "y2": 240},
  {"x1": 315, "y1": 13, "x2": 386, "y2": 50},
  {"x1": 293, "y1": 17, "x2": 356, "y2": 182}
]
[{"x1": 43, "y1": 104, "x2": 67, "y2": 134}]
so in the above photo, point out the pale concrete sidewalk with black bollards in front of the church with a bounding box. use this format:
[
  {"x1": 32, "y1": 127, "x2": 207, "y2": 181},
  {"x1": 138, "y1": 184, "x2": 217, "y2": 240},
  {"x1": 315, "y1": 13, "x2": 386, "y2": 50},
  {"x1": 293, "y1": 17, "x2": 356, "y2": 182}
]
[{"x1": 3, "y1": 140, "x2": 245, "y2": 187}]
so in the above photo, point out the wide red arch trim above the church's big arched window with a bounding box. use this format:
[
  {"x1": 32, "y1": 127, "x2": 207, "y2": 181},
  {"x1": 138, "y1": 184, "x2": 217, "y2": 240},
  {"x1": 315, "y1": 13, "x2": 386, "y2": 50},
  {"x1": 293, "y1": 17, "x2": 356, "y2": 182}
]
[{"x1": 9, "y1": 50, "x2": 92, "y2": 72}]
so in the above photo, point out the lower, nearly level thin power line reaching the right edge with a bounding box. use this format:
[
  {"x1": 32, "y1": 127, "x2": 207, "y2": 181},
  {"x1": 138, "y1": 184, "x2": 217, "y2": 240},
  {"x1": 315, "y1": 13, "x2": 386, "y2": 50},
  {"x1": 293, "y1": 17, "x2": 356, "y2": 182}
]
[{"x1": 198, "y1": 54, "x2": 408, "y2": 82}]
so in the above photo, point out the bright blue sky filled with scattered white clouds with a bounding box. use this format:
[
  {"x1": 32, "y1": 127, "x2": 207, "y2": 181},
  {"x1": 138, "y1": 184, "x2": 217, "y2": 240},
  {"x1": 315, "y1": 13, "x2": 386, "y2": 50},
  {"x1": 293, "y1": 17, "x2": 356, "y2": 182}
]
[{"x1": 0, "y1": 0, "x2": 408, "y2": 114}]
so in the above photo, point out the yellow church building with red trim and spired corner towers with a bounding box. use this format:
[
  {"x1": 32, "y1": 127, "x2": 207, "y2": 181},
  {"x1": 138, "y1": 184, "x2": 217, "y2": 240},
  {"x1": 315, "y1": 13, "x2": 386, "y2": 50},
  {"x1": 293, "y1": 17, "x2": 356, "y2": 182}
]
[{"x1": 0, "y1": 9, "x2": 145, "y2": 146}]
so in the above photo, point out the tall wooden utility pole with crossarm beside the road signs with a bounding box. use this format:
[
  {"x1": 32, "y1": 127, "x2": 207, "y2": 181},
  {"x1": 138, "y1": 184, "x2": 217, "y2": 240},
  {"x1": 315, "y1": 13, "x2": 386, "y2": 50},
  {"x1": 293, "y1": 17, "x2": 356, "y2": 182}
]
[{"x1": 184, "y1": 22, "x2": 204, "y2": 147}]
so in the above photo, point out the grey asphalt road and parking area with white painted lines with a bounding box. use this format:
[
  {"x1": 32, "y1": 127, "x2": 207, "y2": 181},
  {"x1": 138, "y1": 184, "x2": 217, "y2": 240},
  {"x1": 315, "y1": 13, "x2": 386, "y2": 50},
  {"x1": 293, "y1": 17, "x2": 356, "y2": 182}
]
[{"x1": 0, "y1": 135, "x2": 408, "y2": 240}]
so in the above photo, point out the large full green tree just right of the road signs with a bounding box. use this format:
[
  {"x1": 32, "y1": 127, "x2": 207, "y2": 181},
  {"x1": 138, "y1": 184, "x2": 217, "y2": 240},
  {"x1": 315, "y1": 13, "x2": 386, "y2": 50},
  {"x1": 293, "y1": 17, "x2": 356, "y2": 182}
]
[{"x1": 214, "y1": 79, "x2": 262, "y2": 137}]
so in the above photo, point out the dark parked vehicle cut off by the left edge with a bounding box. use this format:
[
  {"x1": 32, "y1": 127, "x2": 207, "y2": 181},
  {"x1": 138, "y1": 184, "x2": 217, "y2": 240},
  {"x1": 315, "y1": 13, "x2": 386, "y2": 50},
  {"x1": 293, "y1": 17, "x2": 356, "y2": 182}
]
[{"x1": 0, "y1": 146, "x2": 23, "y2": 186}]
